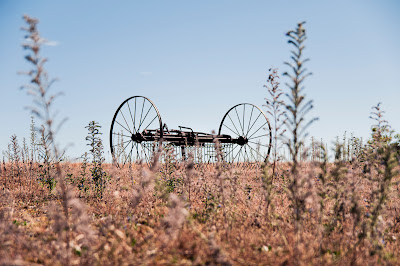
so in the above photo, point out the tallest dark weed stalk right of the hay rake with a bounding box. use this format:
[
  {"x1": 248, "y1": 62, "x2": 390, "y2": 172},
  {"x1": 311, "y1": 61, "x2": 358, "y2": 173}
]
[{"x1": 283, "y1": 22, "x2": 317, "y2": 257}]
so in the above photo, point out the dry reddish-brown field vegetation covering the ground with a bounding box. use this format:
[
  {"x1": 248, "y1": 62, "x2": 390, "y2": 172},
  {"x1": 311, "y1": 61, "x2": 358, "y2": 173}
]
[{"x1": 0, "y1": 162, "x2": 400, "y2": 265}]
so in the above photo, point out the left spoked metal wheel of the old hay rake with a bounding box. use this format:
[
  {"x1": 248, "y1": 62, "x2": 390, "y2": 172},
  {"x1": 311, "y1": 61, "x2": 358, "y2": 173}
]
[{"x1": 110, "y1": 96, "x2": 163, "y2": 165}]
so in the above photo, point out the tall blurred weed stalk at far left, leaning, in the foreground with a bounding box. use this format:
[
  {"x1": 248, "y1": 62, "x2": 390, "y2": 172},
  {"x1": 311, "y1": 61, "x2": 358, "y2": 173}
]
[{"x1": 22, "y1": 15, "x2": 90, "y2": 265}]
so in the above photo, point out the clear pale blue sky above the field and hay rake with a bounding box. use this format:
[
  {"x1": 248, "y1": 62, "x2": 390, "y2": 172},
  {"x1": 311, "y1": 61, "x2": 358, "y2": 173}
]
[{"x1": 0, "y1": 0, "x2": 400, "y2": 158}]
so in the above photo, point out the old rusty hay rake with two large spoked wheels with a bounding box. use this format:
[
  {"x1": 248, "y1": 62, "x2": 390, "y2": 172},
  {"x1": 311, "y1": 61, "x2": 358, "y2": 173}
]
[{"x1": 110, "y1": 96, "x2": 272, "y2": 164}]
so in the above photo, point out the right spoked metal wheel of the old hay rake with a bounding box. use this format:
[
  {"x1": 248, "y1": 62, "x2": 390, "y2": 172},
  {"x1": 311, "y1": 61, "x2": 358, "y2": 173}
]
[{"x1": 218, "y1": 103, "x2": 272, "y2": 163}]
